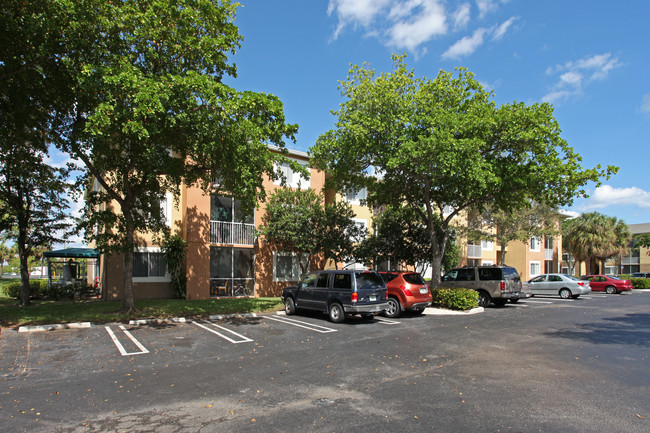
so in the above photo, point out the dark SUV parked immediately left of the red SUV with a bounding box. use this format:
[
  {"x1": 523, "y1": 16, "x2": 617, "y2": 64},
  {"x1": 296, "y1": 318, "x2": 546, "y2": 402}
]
[{"x1": 282, "y1": 270, "x2": 388, "y2": 323}]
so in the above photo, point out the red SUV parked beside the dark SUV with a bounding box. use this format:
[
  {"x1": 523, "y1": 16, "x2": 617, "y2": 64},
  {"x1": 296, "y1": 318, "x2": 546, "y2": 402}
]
[{"x1": 379, "y1": 271, "x2": 431, "y2": 317}]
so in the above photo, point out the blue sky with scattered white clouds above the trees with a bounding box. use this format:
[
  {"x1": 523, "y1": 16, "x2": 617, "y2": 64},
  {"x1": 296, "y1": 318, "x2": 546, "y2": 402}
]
[{"x1": 228, "y1": 0, "x2": 650, "y2": 224}]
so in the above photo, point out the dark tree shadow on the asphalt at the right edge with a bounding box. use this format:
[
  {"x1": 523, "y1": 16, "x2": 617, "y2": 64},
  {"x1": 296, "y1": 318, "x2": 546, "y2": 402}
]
[{"x1": 544, "y1": 313, "x2": 650, "y2": 347}]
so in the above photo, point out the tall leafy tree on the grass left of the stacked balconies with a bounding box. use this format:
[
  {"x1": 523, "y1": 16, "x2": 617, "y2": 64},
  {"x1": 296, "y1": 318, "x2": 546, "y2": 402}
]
[{"x1": 49, "y1": 0, "x2": 297, "y2": 311}]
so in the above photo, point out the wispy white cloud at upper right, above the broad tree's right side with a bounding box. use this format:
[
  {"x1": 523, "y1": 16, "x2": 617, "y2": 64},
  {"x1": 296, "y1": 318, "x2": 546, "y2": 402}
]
[{"x1": 542, "y1": 53, "x2": 622, "y2": 102}]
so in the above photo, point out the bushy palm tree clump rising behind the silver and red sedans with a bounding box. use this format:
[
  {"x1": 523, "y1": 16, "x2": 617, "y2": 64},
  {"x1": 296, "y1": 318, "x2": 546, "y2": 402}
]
[{"x1": 562, "y1": 212, "x2": 632, "y2": 273}]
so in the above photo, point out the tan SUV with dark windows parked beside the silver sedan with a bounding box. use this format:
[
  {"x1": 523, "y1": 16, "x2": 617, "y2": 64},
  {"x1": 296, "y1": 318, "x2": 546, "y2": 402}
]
[{"x1": 440, "y1": 266, "x2": 526, "y2": 307}]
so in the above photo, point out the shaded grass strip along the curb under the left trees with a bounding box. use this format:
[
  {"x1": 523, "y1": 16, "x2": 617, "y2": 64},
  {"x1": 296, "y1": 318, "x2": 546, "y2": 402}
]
[{"x1": 0, "y1": 296, "x2": 283, "y2": 327}]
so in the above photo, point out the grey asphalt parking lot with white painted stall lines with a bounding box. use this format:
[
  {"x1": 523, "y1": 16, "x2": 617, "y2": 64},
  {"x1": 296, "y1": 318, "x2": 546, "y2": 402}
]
[{"x1": 0, "y1": 292, "x2": 650, "y2": 432}]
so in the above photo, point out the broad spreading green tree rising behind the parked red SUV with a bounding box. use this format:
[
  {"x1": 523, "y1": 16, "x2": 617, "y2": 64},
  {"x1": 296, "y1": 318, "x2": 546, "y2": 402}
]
[{"x1": 311, "y1": 56, "x2": 616, "y2": 283}]
